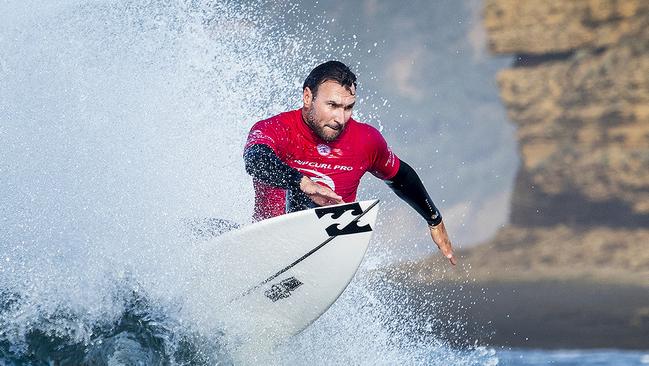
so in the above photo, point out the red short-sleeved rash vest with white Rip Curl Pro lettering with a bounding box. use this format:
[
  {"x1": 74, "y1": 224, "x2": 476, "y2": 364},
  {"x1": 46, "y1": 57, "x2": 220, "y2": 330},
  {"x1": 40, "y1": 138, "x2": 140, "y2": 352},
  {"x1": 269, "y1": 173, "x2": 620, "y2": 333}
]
[{"x1": 245, "y1": 109, "x2": 399, "y2": 220}]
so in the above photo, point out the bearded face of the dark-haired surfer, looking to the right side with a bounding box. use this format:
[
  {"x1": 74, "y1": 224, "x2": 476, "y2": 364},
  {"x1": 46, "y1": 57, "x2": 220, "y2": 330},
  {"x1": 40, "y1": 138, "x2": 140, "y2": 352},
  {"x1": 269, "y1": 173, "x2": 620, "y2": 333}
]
[{"x1": 303, "y1": 80, "x2": 356, "y2": 142}]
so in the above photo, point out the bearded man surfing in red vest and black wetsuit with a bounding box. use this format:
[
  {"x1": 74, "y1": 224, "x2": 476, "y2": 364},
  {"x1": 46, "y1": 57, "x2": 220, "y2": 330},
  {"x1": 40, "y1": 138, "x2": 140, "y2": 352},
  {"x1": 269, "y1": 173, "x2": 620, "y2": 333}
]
[{"x1": 244, "y1": 61, "x2": 456, "y2": 265}]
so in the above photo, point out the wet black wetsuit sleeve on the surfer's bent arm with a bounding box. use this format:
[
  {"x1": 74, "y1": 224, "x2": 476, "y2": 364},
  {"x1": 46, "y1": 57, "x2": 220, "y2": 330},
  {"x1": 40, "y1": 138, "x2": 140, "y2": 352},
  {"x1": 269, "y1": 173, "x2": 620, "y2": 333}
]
[{"x1": 243, "y1": 144, "x2": 303, "y2": 190}]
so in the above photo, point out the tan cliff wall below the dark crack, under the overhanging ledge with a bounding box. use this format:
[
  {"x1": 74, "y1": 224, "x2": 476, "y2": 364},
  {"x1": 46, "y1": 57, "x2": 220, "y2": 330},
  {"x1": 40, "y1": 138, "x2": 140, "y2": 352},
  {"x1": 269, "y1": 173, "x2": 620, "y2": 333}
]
[{"x1": 506, "y1": 43, "x2": 649, "y2": 222}]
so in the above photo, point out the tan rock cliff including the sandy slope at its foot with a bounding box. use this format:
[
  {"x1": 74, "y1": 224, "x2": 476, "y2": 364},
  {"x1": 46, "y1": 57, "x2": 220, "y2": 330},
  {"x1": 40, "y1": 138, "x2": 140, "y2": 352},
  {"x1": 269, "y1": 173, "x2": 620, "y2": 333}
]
[{"x1": 458, "y1": 0, "x2": 649, "y2": 285}]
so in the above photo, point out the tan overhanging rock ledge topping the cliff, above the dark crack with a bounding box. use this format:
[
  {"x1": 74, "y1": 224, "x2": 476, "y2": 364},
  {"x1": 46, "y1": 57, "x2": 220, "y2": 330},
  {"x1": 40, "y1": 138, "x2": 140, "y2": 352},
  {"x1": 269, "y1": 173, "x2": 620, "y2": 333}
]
[{"x1": 484, "y1": 0, "x2": 649, "y2": 55}]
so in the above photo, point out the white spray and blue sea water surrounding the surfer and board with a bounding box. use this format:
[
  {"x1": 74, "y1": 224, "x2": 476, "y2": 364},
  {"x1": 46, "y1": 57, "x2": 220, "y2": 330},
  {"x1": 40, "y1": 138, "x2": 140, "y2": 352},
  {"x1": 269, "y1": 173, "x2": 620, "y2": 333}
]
[{"x1": 0, "y1": 0, "x2": 647, "y2": 365}]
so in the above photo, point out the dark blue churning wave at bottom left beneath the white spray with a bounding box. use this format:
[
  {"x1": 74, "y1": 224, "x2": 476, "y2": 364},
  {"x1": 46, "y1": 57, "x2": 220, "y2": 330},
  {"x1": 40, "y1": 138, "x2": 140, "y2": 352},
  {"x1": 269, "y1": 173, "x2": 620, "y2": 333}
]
[{"x1": 0, "y1": 281, "x2": 231, "y2": 365}]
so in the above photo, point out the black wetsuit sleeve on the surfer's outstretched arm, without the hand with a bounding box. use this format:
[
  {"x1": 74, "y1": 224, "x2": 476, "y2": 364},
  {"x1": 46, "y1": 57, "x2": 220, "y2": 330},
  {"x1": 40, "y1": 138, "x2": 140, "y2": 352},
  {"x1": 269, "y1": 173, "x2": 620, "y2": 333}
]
[{"x1": 386, "y1": 160, "x2": 442, "y2": 226}]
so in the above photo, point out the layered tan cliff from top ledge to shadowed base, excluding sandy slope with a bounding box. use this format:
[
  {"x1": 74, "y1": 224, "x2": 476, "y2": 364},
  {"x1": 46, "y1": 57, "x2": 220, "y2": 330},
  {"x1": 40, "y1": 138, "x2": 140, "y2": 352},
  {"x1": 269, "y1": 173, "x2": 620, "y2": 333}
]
[{"x1": 485, "y1": 0, "x2": 649, "y2": 226}]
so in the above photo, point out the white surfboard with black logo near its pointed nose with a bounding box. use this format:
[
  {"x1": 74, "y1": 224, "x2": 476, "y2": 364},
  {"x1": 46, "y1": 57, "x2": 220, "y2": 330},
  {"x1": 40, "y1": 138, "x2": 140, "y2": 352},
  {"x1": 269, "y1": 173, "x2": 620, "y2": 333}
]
[{"x1": 207, "y1": 200, "x2": 379, "y2": 345}]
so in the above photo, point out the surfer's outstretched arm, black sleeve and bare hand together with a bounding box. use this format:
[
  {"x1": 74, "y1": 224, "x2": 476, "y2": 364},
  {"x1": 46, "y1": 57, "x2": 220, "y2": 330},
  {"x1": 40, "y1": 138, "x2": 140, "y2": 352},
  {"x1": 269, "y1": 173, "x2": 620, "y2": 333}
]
[{"x1": 386, "y1": 160, "x2": 457, "y2": 265}]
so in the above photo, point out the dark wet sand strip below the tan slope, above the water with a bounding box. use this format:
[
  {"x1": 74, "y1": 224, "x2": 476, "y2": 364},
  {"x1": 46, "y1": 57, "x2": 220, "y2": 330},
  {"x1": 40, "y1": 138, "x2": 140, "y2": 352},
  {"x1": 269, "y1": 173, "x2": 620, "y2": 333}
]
[{"x1": 404, "y1": 281, "x2": 649, "y2": 350}]
